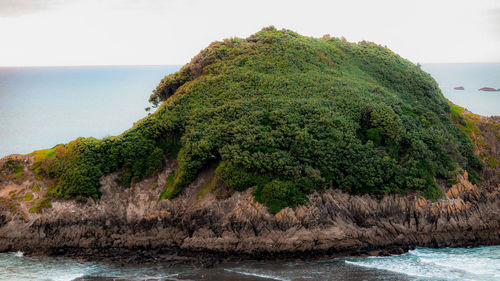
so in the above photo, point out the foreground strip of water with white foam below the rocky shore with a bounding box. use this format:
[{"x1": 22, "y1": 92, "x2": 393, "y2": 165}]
[{"x1": 0, "y1": 246, "x2": 500, "y2": 281}]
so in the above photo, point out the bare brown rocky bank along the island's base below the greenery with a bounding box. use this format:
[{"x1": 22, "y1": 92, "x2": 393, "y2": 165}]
[{"x1": 0, "y1": 111, "x2": 500, "y2": 265}]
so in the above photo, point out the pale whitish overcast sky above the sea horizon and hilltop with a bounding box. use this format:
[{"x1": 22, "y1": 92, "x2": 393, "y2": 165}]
[{"x1": 0, "y1": 0, "x2": 500, "y2": 66}]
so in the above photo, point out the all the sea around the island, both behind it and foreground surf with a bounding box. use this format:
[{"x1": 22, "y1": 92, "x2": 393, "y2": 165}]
[{"x1": 0, "y1": 64, "x2": 500, "y2": 281}]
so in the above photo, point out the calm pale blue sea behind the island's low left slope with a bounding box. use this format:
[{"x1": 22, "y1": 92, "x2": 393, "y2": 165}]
[{"x1": 0, "y1": 66, "x2": 180, "y2": 157}]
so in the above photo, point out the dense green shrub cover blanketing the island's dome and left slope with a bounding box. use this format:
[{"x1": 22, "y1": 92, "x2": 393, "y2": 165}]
[{"x1": 33, "y1": 27, "x2": 482, "y2": 212}]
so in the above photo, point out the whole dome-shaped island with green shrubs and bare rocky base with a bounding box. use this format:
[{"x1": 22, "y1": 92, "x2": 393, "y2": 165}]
[{"x1": 0, "y1": 27, "x2": 500, "y2": 263}]
